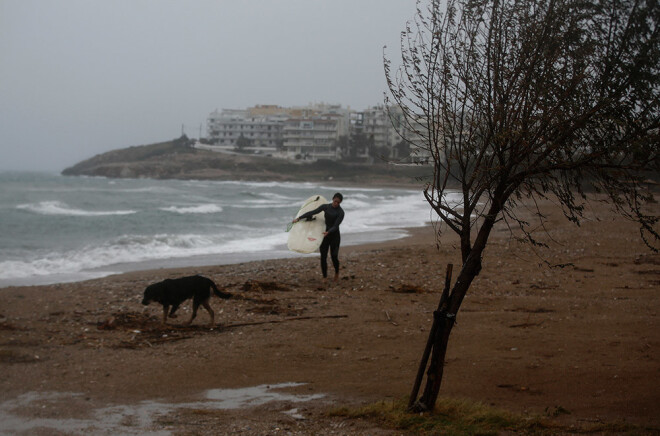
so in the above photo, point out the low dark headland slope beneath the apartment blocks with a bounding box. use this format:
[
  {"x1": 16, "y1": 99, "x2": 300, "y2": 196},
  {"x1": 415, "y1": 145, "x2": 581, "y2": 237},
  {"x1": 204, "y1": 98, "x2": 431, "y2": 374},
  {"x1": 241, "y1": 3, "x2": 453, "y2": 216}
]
[{"x1": 62, "y1": 137, "x2": 429, "y2": 185}]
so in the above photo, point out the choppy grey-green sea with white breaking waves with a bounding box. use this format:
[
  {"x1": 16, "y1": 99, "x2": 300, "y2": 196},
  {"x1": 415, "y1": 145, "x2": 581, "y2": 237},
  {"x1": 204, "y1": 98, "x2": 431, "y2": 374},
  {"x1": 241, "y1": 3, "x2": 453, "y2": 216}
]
[{"x1": 0, "y1": 171, "x2": 454, "y2": 287}]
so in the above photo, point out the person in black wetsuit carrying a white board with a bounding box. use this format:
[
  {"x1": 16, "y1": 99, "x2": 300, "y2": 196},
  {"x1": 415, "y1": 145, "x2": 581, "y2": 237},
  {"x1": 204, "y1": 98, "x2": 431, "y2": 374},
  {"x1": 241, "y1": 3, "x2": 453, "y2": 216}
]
[{"x1": 293, "y1": 192, "x2": 344, "y2": 281}]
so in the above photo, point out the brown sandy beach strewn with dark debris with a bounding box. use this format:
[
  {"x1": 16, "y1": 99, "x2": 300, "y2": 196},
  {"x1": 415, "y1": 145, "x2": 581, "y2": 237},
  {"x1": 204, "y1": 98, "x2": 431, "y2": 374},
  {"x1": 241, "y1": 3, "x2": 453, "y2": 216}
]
[{"x1": 0, "y1": 196, "x2": 660, "y2": 435}]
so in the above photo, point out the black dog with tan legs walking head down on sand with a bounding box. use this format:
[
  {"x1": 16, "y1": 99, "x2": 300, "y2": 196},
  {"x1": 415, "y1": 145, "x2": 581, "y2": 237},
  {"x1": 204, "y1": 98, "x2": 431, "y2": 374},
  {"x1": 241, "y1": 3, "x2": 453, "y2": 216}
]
[{"x1": 142, "y1": 275, "x2": 231, "y2": 327}]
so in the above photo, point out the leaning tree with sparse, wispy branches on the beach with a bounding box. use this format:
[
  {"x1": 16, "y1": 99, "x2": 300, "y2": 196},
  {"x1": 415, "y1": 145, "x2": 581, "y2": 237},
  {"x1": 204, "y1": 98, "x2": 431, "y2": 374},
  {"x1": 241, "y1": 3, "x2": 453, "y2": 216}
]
[{"x1": 385, "y1": 0, "x2": 660, "y2": 410}]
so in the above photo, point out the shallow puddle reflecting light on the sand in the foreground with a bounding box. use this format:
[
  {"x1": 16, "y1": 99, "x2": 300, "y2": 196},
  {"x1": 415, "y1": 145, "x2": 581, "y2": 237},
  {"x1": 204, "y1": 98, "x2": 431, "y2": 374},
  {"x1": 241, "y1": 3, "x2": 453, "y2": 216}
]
[{"x1": 0, "y1": 383, "x2": 325, "y2": 436}]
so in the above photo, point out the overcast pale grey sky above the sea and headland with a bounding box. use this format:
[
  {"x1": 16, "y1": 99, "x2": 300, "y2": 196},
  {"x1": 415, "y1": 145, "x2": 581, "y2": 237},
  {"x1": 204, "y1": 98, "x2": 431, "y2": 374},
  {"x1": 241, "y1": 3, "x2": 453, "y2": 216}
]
[{"x1": 0, "y1": 0, "x2": 415, "y2": 171}]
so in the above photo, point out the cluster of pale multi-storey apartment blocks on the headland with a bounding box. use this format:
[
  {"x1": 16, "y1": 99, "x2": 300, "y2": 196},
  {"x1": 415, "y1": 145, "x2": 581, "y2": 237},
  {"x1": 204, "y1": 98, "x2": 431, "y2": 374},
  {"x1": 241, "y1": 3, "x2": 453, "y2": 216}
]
[{"x1": 202, "y1": 103, "x2": 428, "y2": 162}]
